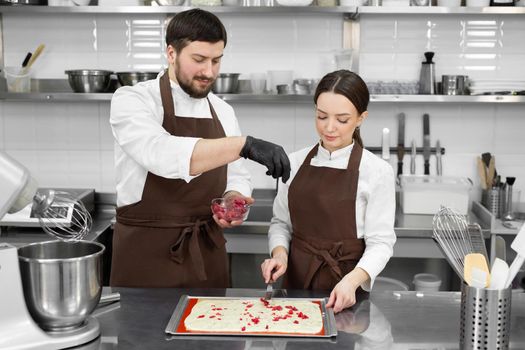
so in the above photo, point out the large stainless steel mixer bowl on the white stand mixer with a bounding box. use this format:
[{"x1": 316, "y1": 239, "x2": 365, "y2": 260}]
[{"x1": 18, "y1": 241, "x2": 105, "y2": 331}]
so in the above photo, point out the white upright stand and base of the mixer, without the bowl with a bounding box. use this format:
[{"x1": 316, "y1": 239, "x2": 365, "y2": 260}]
[{"x1": 0, "y1": 243, "x2": 100, "y2": 350}]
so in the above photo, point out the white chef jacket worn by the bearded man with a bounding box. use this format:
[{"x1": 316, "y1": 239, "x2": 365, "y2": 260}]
[{"x1": 110, "y1": 72, "x2": 252, "y2": 206}]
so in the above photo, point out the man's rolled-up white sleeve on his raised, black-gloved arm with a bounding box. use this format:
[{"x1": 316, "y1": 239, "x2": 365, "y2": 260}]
[{"x1": 110, "y1": 87, "x2": 199, "y2": 182}]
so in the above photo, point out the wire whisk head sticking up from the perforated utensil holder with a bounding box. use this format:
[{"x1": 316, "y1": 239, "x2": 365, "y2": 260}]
[{"x1": 432, "y1": 206, "x2": 476, "y2": 280}]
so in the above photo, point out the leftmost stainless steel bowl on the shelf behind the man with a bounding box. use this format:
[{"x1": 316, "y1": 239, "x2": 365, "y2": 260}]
[{"x1": 65, "y1": 69, "x2": 113, "y2": 92}]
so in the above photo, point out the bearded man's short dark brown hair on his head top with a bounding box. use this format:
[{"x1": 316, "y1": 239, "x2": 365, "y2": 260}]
[{"x1": 166, "y1": 9, "x2": 227, "y2": 53}]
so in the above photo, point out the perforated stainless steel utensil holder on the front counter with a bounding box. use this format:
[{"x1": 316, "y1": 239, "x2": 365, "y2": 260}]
[{"x1": 459, "y1": 284, "x2": 512, "y2": 350}]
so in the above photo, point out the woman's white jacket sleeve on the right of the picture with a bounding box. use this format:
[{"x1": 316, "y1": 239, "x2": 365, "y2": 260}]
[{"x1": 357, "y1": 165, "x2": 396, "y2": 290}]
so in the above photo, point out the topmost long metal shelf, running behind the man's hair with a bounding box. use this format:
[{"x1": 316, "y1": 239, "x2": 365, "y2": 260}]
[{"x1": 0, "y1": 6, "x2": 525, "y2": 18}]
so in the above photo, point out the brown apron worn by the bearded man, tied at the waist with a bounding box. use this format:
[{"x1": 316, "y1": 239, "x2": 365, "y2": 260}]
[{"x1": 110, "y1": 71, "x2": 229, "y2": 288}]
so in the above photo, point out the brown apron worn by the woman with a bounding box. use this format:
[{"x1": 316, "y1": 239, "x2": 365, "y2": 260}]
[{"x1": 283, "y1": 142, "x2": 365, "y2": 289}]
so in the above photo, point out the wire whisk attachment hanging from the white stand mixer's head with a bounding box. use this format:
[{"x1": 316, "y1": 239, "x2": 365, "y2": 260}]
[{"x1": 32, "y1": 190, "x2": 93, "y2": 241}]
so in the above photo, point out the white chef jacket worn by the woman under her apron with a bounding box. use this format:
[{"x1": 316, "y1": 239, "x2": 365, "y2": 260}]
[{"x1": 268, "y1": 144, "x2": 396, "y2": 290}]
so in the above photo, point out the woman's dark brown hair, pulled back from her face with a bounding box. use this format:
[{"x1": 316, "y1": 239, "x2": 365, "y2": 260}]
[{"x1": 314, "y1": 69, "x2": 370, "y2": 147}]
